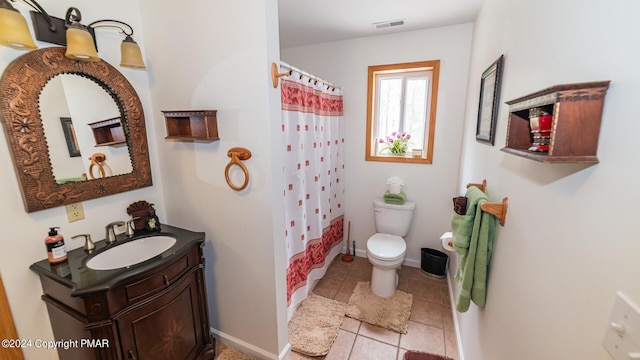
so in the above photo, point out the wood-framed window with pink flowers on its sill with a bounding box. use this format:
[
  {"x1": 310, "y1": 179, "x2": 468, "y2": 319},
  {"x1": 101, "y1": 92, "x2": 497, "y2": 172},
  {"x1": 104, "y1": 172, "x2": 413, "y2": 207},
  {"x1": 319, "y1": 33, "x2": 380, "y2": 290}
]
[{"x1": 365, "y1": 60, "x2": 440, "y2": 164}]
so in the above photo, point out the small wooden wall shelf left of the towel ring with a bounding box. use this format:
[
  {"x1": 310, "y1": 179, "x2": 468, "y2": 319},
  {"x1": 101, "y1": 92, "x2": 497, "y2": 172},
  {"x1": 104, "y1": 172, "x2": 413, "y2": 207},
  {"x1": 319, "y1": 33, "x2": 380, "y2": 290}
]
[{"x1": 162, "y1": 110, "x2": 220, "y2": 142}]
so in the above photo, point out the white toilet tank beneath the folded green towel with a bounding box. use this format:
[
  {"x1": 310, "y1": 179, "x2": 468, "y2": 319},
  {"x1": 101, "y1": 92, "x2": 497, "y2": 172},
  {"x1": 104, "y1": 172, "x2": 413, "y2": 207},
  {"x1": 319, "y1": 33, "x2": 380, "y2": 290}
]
[{"x1": 373, "y1": 199, "x2": 416, "y2": 237}]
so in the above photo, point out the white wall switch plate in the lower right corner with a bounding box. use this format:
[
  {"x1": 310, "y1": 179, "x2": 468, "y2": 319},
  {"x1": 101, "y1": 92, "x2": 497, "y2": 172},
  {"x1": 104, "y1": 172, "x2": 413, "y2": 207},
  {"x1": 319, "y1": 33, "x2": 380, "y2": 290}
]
[{"x1": 603, "y1": 291, "x2": 640, "y2": 360}]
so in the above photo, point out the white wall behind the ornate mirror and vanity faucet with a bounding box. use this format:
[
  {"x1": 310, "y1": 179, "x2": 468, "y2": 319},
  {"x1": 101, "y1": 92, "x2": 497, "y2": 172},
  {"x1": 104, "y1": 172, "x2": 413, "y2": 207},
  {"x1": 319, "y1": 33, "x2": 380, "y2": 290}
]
[{"x1": 0, "y1": 0, "x2": 166, "y2": 359}]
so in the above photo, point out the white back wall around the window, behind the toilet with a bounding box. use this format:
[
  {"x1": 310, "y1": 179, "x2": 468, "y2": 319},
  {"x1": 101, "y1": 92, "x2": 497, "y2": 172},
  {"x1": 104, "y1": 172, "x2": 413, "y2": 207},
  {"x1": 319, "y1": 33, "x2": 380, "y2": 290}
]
[{"x1": 281, "y1": 24, "x2": 472, "y2": 267}]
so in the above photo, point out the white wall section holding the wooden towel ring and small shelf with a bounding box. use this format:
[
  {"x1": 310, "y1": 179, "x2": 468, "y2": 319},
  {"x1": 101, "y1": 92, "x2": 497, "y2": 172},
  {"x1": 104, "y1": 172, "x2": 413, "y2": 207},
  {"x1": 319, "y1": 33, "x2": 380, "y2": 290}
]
[{"x1": 140, "y1": 0, "x2": 287, "y2": 358}]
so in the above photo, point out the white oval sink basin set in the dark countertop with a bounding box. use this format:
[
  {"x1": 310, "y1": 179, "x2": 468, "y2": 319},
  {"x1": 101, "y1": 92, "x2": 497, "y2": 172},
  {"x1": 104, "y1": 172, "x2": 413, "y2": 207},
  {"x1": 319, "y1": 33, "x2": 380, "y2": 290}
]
[{"x1": 87, "y1": 235, "x2": 176, "y2": 270}]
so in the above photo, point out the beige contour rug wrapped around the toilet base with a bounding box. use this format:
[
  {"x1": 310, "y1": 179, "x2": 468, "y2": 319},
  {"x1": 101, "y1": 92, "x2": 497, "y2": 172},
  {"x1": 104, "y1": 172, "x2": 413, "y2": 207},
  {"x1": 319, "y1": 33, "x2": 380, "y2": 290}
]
[{"x1": 347, "y1": 281, "x2": 413, "y2": 334}]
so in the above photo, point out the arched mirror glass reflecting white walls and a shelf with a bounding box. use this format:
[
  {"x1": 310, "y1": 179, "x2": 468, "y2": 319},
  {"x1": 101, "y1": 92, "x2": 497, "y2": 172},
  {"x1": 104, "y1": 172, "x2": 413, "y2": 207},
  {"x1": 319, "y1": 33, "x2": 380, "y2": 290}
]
[{"x1": 38, "y1": 74, "x2": 133, "y2": 184}]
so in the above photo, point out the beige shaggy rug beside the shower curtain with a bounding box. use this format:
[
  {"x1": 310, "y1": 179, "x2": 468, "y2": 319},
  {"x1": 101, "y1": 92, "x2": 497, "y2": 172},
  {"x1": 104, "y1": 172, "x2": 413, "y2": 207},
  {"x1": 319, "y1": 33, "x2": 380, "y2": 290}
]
[{"x1": 289, "y1": 293, "x2": 347, "y2": 356}]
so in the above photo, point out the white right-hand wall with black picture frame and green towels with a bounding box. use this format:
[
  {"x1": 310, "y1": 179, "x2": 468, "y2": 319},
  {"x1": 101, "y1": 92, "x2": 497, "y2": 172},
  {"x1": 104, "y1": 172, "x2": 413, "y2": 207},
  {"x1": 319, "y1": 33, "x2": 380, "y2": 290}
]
[{"x1": 458, "y1": 0, "x2": 640, "y2": 360}]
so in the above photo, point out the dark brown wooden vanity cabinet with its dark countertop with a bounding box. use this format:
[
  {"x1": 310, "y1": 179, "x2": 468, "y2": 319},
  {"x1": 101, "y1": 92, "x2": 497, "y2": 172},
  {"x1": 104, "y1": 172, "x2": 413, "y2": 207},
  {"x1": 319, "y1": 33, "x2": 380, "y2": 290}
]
[{"x1": 31, "y1": 225, "x2": 215, "y2": 360}]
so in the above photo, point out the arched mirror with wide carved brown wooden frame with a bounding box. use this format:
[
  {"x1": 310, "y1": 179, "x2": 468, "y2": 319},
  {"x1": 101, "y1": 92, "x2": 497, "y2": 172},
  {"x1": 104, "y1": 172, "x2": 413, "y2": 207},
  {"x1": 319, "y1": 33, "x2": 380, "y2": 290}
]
[{"x1": 0, "y1": 47, "x2": 152, "y2": 212}]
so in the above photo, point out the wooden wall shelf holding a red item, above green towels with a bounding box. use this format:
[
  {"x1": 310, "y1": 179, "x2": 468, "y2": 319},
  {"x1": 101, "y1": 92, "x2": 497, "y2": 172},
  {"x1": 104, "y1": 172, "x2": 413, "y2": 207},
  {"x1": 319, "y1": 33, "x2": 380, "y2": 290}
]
[{"x1": 501, "y1": 81, "x2": 610, "y2": 164}]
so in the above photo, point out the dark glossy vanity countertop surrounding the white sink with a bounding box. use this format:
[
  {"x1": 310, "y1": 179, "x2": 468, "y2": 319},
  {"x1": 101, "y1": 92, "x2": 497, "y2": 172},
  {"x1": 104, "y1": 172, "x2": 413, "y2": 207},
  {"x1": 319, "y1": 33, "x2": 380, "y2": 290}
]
[{"x1": 29, "y1": 224, "x2": 205, "y2": 296}]
